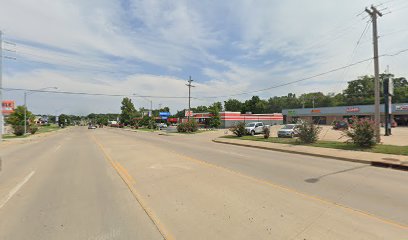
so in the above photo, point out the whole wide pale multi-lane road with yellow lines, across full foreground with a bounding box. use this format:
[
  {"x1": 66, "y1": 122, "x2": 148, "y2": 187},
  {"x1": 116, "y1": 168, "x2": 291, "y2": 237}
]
[{"x1": 0, "y1": 127, "x2": 408, "y2": 239}]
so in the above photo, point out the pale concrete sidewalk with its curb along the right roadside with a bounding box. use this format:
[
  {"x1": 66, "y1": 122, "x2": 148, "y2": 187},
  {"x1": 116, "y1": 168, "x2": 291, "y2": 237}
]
[{"x1": 213, "y1": 138, "x2": 408, "y2": 169}]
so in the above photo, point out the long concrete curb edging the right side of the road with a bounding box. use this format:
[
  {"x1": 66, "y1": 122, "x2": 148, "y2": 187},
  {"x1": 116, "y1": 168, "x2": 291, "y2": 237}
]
[{"x1": 212, "y1": 139, "x2": 408, "y2": 171}]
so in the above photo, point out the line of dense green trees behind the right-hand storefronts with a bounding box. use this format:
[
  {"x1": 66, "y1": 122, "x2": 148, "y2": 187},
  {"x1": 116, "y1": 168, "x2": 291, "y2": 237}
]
[{"x1": 175, "y1": 74, "x2": 408, "y2": 114}]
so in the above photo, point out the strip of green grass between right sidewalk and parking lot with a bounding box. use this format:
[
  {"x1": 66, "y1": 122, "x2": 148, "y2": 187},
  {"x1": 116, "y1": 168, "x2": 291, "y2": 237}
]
[{"x1": 222, "y1": 136, "x2": 408, "y2": 156}]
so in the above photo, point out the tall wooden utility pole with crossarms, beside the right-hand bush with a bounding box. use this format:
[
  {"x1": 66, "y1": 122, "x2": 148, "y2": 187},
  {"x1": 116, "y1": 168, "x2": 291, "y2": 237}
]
[{"x1": 365, "y1": 5, "x2": 382, "y2": 143}]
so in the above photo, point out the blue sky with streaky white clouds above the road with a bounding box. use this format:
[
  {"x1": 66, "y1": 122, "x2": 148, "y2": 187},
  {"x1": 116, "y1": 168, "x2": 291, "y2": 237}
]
[{"x1": 0, "y1": 0, "x2": 408, "y2": 115}]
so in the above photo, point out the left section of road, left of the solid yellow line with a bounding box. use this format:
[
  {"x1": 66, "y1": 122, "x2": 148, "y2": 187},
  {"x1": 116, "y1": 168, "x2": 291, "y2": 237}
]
[{"x1": 0, "y1": 128, "x2": 163, "y2": 240}]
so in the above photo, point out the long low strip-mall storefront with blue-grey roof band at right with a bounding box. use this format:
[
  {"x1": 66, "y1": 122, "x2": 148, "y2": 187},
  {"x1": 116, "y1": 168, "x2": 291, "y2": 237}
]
[{"x1": 282, "y1": 103, "x2": 408, "y2": 126}]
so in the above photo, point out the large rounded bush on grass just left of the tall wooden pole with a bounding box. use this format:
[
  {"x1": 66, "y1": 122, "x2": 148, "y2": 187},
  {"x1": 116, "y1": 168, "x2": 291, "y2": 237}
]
[{"x1": 346, "y1": 118, "x2": 376, "y2": 147}]
